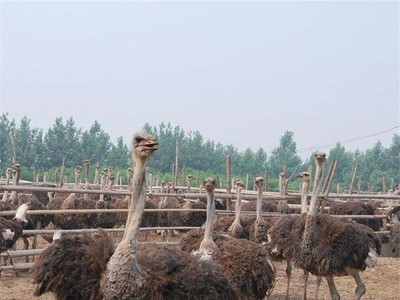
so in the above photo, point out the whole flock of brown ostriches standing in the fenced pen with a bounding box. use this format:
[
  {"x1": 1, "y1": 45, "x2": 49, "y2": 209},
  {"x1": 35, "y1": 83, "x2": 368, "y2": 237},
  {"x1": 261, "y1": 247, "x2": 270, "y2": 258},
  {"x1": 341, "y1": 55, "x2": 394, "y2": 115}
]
[{"x1": 0, "y1": 132, "x2": 400, "y2": 300}]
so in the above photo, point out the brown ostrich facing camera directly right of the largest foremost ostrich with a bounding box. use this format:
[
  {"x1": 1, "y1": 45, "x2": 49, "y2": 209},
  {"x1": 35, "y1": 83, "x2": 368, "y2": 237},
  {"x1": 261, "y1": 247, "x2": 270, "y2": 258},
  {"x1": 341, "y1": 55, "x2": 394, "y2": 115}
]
[{"x1": 179, "y1": 178, "x2": 275, "y2": 299}]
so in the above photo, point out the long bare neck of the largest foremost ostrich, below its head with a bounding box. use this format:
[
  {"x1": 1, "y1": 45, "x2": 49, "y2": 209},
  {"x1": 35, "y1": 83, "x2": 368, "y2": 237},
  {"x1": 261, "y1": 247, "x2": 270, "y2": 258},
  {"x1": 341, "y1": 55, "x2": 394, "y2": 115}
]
[{"x1": 124, "y1": 159, "x2": 146, "y2": 245}]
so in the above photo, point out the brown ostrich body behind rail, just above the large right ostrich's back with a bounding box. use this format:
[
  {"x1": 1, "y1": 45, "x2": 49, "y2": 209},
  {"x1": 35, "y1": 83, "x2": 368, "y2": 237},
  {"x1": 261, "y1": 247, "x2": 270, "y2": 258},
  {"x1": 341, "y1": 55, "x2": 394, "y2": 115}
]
[{"x1": 328, "y1": 201, "x2": 383, "y2": 231}]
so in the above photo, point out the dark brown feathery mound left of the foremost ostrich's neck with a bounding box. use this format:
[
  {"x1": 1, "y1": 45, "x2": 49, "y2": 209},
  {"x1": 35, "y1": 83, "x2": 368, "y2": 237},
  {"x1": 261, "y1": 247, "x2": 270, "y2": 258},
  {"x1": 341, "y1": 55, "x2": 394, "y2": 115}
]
[{"x1": 31, "y1": 229, "x2": 114, "y2": 300}]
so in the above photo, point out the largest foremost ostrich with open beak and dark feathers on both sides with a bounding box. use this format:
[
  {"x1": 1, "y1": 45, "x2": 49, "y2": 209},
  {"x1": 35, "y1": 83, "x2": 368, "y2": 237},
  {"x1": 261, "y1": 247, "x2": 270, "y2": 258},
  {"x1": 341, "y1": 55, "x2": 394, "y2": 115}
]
[{"x1": 32, "y1": 132, "x2": 238, "y2": 300}]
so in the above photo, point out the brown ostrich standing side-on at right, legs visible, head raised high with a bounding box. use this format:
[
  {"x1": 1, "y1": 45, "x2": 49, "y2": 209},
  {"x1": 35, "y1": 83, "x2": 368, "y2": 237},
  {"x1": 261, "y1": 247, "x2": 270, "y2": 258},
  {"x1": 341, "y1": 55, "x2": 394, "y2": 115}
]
[{"x1": 270, "y1": 153, "x2": 381, "y2": 300}]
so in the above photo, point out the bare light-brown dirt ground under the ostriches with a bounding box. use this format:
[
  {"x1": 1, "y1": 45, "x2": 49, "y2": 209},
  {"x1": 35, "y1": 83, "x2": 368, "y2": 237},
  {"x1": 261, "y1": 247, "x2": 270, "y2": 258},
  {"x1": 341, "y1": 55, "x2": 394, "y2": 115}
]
[{"x1": 0, "y1": 234, "x2": 400, "y2": 300}]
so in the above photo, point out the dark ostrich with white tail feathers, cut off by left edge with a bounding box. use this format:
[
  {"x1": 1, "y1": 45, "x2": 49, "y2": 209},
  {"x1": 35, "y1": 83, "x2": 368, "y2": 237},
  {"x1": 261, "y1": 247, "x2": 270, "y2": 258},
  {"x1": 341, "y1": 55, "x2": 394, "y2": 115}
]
[{"x1": 0, "y1": 204, "x2": 28, "y2": 253}]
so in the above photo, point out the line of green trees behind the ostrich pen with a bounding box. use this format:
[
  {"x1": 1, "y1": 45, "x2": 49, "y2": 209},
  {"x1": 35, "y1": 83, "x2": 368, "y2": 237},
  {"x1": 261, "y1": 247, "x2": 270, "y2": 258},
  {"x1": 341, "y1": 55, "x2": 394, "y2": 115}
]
[{"x1": 0, "y1": 113, "x2": 400, "y2": 191}]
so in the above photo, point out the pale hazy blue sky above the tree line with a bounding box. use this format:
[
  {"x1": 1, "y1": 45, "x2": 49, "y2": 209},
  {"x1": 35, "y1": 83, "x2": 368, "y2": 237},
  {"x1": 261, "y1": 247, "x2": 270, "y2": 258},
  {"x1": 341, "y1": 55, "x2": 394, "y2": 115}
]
[{"x1": 0, "y1": 1, "x2": 400, "y2": 156}]
